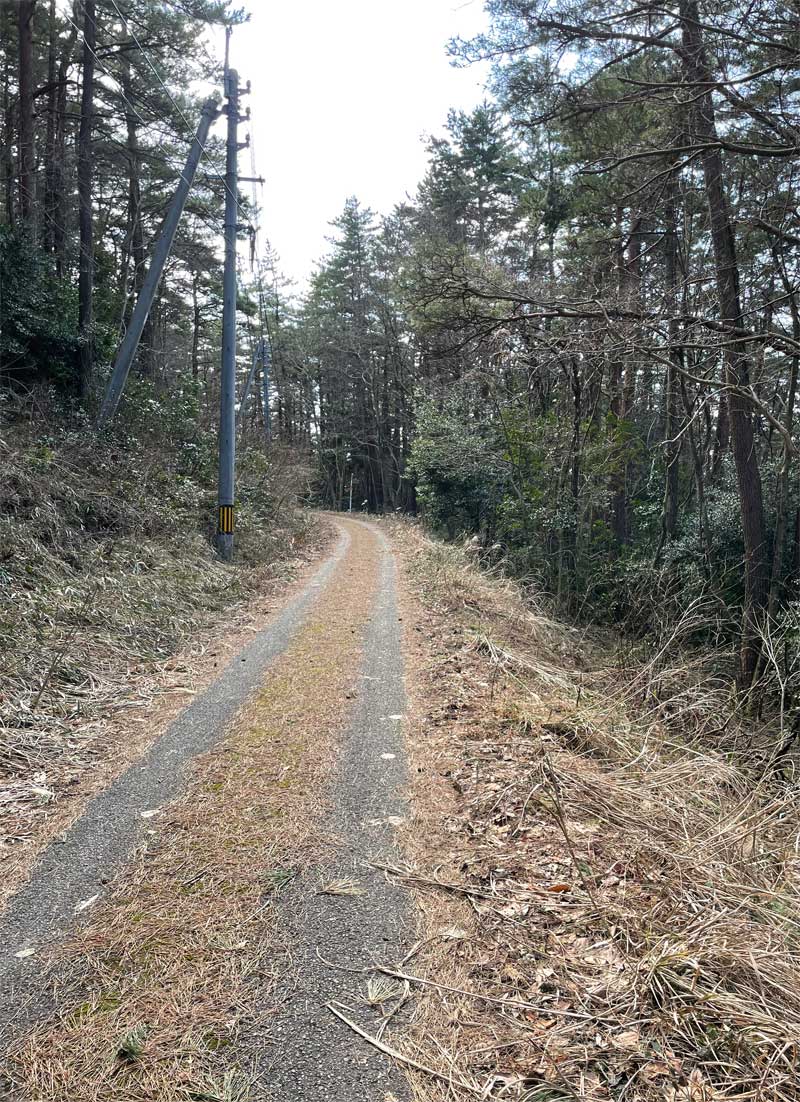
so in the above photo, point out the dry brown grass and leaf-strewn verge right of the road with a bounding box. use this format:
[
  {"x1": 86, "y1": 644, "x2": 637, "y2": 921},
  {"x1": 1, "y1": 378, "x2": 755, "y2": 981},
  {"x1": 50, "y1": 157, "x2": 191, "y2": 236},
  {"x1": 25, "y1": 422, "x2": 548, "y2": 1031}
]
[{"x1": 381, "y1": 526, "x2": 800, "y2": 1102}]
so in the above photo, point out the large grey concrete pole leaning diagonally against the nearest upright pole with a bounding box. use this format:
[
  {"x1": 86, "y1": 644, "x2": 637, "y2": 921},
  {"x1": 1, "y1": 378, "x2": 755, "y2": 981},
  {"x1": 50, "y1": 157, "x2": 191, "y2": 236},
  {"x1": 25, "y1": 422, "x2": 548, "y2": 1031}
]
[{"x1": 97, "y1": 99, "x2": 220, "y2": 429}]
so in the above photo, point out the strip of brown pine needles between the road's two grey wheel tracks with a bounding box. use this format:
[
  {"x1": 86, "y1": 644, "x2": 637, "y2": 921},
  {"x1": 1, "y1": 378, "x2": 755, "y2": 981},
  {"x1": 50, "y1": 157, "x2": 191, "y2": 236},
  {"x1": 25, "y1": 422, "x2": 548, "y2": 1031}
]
[{"x1": 4, "y1": 517, "x2": 378, "y2": 1102}]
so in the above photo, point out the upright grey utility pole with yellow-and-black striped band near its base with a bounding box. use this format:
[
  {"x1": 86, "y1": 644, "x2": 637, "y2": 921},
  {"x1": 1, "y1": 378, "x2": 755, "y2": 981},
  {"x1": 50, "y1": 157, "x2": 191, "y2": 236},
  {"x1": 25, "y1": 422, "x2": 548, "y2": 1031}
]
[{"x1": 217, "y1": 68, "x2": 239, "y2": 562}]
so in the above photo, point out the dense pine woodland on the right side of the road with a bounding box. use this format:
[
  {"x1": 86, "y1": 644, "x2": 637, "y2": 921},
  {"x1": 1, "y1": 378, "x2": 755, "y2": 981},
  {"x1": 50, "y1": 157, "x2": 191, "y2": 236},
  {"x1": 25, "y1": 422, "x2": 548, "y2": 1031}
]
[{"x1": 288, "y1": 0, "x2": 800, "y2": 705}]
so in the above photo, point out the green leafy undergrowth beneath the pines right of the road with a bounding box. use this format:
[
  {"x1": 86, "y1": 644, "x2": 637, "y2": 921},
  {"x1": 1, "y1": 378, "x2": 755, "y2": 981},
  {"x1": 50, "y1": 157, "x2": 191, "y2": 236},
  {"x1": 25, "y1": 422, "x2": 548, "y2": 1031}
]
[{"x1": 410, "y1": 380, "x2": 800, "y2": 656}]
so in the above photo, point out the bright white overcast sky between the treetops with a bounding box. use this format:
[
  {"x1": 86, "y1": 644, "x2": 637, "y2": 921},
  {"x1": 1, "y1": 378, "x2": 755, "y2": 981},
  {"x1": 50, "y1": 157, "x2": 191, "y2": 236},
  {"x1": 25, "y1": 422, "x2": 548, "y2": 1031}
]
[{"x1": 223, "y1": 0, "x2": 486, "y2": 284}]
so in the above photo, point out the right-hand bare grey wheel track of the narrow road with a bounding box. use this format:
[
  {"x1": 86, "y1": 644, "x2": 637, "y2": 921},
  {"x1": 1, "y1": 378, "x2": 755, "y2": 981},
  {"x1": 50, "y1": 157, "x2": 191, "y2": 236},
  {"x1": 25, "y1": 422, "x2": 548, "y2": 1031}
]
[{"x1": 249, "y1": 526, "x2": 413, "y2": 1102}]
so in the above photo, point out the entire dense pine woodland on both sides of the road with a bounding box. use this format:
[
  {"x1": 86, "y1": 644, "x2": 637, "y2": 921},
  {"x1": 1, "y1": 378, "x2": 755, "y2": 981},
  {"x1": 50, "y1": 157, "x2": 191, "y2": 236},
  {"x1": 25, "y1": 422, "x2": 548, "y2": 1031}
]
[{"x1": 0, "y1": 0, "x2": 800, "y2": 691}]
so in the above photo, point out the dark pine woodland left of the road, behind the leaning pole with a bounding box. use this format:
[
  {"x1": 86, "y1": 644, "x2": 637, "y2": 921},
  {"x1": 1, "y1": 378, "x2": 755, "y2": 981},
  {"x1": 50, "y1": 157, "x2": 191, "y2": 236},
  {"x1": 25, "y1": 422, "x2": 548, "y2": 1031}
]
[{"x1": 0, "y1": 0, "x2": 245, "y2": 412}]
